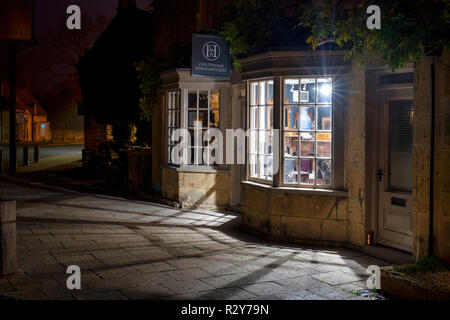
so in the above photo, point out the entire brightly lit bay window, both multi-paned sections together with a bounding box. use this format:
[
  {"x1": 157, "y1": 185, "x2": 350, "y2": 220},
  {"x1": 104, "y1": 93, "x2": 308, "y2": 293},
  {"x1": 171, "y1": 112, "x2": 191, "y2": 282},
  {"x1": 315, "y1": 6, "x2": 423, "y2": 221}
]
[{"x1": 248, "y1": 76, "x2": 344, "y2": 188}]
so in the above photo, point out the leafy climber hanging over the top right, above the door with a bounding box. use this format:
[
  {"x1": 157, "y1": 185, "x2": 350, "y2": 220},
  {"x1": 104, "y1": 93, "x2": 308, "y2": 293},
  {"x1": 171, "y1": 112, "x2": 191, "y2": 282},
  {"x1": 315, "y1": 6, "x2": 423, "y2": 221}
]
[{"x1": 300, "y1": 0, "x2": 450, "y2": 70}]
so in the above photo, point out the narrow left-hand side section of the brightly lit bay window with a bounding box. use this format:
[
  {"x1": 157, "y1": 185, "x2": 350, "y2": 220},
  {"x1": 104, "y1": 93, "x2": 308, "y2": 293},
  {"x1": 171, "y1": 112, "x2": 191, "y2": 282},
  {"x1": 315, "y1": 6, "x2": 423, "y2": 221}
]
[{"x1": 249, "y1": 80, "x2": 274, "y2": 180}]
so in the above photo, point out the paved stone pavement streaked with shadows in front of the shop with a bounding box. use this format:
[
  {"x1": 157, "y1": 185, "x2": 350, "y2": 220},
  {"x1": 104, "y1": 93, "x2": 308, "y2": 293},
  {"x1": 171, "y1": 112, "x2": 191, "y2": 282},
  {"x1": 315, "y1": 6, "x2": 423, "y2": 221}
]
[{"x1": 0, "y1": 177, "x2": 388, "y2": 300}]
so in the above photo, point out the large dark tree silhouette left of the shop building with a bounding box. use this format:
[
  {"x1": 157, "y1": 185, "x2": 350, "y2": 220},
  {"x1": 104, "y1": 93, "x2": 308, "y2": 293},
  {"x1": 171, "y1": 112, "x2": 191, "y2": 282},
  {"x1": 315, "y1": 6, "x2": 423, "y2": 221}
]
[{"x1": 77, "y1": 9, "x2": 153, "y2": 143}]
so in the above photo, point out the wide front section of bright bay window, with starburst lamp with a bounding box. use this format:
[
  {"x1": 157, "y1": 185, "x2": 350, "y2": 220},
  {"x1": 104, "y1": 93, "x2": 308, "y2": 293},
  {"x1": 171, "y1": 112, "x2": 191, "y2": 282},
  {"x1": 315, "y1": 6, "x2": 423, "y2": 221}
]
[{"x1": 283, "y1": 78, "x2": 333, "y2": 186}]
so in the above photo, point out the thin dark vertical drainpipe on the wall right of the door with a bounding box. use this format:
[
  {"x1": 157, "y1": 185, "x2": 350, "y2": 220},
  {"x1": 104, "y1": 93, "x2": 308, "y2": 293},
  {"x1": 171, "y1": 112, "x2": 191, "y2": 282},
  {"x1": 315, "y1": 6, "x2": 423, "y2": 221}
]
[{"x1": 428, "y1": 55, "x2": 436, "y2": 257}]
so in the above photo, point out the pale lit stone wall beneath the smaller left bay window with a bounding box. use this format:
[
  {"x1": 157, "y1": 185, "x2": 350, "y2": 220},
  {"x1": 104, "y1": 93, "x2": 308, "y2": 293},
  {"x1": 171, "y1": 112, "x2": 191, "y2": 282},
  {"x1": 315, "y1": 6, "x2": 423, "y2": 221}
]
[{"x1": 162, "y1": 167, "x2": 231, "y2": 209}]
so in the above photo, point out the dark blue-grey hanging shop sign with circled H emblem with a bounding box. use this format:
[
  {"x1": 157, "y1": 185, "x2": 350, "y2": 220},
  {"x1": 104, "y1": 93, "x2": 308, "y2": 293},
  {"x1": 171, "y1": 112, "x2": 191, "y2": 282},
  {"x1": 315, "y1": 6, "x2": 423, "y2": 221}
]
[{"x1": 191, "y1": 33, "x2": 231, "y2": 78}]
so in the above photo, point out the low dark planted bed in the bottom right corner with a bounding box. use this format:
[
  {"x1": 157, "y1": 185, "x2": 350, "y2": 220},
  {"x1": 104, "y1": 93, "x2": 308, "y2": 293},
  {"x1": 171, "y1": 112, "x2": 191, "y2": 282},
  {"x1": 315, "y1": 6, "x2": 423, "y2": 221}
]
[{"x1": 381, "y1": 266, "x2": 450, "y2": 300}]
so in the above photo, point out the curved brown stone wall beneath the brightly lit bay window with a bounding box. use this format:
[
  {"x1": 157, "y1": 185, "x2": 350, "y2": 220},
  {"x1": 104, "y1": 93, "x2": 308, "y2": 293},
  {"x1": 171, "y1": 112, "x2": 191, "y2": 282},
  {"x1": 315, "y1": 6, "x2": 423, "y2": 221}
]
[{"x1": 242, "y1": 184, "x2": 349, "y2": 245}]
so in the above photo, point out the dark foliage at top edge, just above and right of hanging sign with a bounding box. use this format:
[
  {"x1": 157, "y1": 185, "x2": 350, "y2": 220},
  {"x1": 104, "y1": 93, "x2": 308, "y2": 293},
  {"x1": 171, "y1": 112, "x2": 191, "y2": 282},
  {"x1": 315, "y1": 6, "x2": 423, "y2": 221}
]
[{"x1": 221, "y1": 0, "x2": 305, "y2": 70}]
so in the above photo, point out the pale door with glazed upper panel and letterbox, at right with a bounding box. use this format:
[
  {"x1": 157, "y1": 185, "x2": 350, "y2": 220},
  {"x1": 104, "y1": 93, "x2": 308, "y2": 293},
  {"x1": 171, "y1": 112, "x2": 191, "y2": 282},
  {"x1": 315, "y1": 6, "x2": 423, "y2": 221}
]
[{"x1": 377, "y1": 96, "x2": 413, "y2": 252}]
